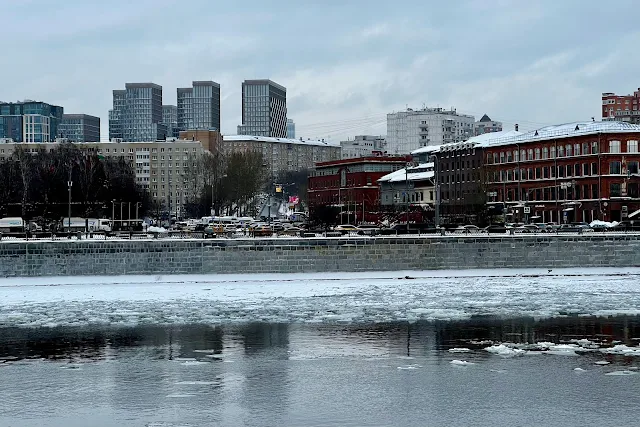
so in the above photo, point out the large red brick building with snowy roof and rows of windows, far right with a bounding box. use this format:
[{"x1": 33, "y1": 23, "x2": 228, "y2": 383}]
[{"x1": 479, "y1": 121, "x2": 640, "y2": 223}]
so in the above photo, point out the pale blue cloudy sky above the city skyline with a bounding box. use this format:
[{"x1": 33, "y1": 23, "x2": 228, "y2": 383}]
[{"x1": 0, "y1": 0, "x2": 640, "y2": 141}]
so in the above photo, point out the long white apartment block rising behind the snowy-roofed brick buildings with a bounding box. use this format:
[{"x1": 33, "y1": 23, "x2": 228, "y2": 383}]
[{"x1": 387, "y1": 108, "x2": 475, "y2": 155}]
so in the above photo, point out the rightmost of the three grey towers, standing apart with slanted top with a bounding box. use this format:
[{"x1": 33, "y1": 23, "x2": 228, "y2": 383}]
[{"x1": 238, "y1": 80, "x2": 287, "y2": 138}]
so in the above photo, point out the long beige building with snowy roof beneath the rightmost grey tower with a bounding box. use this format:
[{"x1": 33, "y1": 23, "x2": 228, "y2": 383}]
[{"x1": 222, "y1": 135, "x2": 340, "y2": 178}]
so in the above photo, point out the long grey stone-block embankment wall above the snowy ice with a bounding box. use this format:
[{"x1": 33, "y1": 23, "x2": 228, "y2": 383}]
[{"x1": 0, "y1": 235, "x2": 640, "y2": 277}]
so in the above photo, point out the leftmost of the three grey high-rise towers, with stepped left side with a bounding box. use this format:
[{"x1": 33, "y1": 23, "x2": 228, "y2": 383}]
[{"x1": 109, "y1": 83, "x2": 167, "y2": 142}]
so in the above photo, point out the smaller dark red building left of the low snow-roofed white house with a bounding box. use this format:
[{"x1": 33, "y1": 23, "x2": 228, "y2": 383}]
[{"x1": 307, "y1": 156, "x2": 411, "y2": 223}]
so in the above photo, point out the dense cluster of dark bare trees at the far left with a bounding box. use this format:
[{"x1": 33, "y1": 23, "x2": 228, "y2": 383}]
[{"x1": 0, "y1": 144, "x2": 150, "y2": 220}]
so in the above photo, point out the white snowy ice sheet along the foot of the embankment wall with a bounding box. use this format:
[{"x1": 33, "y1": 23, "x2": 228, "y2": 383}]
[{"x1": 0, "y1": 268, "x2": 640, "y2": 326}]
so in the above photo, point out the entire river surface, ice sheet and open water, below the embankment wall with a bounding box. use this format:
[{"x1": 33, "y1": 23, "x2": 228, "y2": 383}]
[{"x1": 0, "y1": 269, "x2": 640, "y2": 427}]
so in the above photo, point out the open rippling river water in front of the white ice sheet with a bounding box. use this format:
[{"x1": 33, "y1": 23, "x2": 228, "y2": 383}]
[{"x1": 0, "y1": 317, "x2": 640, "y2": 427}]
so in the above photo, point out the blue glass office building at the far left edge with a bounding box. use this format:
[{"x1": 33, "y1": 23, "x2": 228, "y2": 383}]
[{"x1": 0, "y1": 100, "x2": 64, "y2": 143}]
